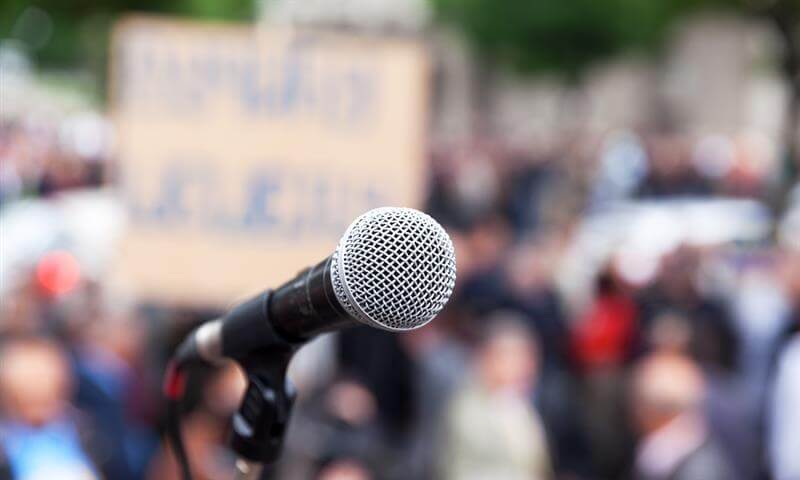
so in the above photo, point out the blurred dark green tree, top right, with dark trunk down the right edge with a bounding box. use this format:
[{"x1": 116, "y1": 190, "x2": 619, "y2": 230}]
[{"x1": 431, "y1": 0, "x2": 800, "y2": 195}]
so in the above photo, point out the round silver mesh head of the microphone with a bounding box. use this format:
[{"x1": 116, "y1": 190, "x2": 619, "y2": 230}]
[{"x1": 331, "y1": 207, "x2": 456, "y2": 331}]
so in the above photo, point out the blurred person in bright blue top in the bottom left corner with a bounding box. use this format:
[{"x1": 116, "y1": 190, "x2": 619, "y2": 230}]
[{"x1": 0, "y1": 337, "x2": 101, "y2": 480}]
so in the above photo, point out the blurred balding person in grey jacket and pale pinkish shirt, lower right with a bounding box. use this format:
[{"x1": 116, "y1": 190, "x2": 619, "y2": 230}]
[{"x1": 631, "y1": 353, "x2": 737, "y2": 480}]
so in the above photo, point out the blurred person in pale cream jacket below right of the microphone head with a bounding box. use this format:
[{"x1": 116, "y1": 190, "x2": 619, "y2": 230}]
[{"x1": 441, "y1": 318, "x2": 553, "y2": 480}]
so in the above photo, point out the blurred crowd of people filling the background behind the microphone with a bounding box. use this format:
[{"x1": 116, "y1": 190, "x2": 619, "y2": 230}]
[{"x1": 0, "y1": 113, "x2": 800, "y2": 480}]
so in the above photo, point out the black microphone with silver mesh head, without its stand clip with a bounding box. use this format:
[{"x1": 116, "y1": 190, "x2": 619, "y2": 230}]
[{"x1": 176, "y1": 207, "x2": 456, "y2": 363}]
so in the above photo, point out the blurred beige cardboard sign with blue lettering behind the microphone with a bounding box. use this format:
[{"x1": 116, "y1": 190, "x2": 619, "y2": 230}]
[{"x1": 111, "y1": 18, "x2": 426, "y2": 305}]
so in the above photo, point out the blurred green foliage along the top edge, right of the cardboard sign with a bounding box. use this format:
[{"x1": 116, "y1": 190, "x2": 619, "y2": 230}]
[{"x1": 431, "y1": 0, "x2": 742, "y2": 79}]
